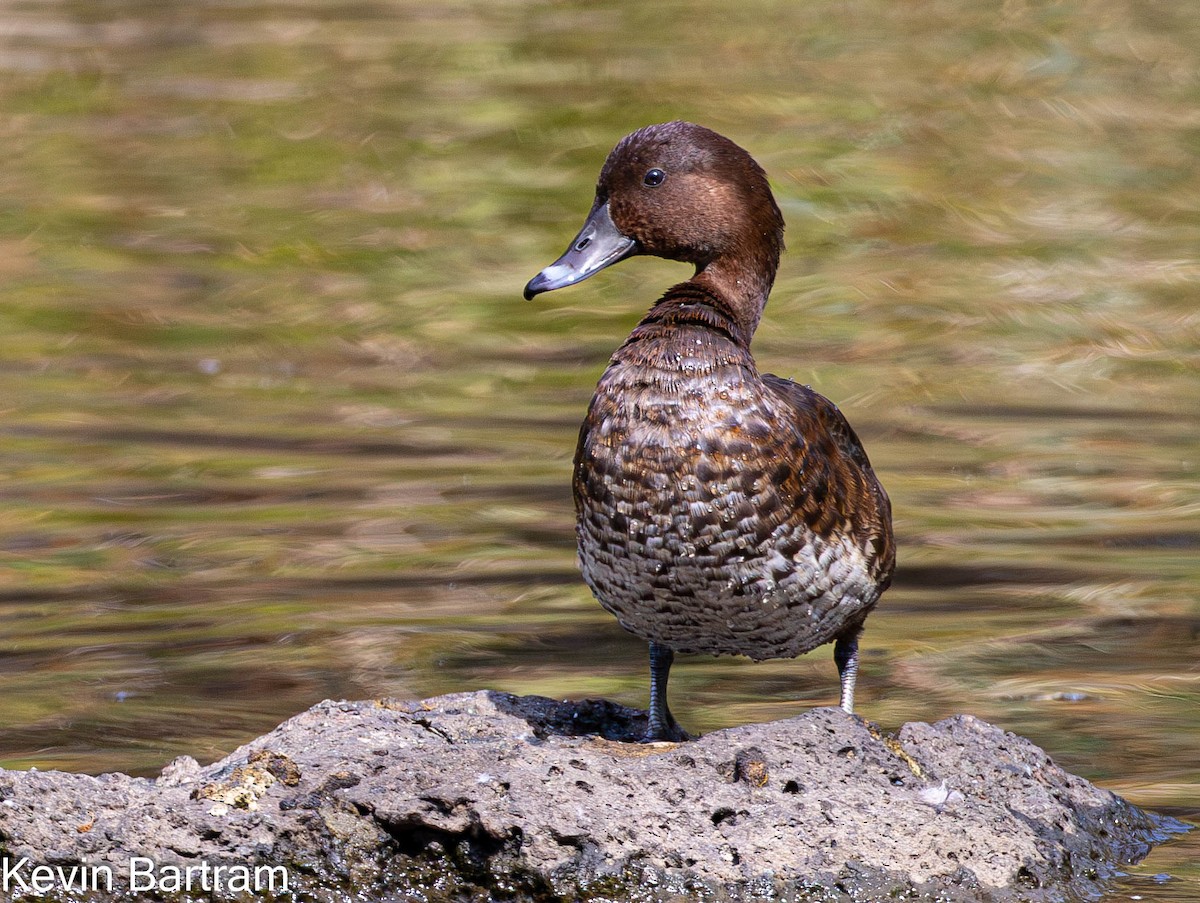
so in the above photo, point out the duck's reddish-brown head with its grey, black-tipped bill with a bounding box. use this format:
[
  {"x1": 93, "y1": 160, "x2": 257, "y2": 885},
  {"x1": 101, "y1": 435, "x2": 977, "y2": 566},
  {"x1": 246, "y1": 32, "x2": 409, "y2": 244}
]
[{"x1": 524, "y1": 121, "x2": 784, "y2": 304}]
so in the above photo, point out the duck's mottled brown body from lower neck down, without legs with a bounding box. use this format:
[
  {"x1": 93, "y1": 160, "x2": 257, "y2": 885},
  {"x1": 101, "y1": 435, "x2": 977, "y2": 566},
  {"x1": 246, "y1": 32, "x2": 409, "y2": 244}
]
[{"x1": 574, "y1": 291, "x2": 894, "y2": 659}]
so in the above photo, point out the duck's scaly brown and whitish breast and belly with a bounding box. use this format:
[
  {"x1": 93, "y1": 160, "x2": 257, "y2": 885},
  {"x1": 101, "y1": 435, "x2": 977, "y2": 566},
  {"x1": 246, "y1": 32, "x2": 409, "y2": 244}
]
[{"x1": 574, "y1": 341, "x2": 878, "y2": 658}]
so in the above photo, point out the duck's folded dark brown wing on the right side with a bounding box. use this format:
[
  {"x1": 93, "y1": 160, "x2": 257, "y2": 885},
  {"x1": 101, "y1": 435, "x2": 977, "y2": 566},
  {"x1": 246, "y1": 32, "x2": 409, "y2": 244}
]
[{"x1": 762, "y1": 373, "x2": 895, "y2": 592}]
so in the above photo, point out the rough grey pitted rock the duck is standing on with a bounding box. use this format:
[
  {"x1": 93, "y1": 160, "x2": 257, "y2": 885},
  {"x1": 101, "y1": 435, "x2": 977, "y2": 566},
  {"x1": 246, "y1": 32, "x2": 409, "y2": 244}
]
[{"x1": 0, "y1": 692, "x2": 1183, "y2": 901}]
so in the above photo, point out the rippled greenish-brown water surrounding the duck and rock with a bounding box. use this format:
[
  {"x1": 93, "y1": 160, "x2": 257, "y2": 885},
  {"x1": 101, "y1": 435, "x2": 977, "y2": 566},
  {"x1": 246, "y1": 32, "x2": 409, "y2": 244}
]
[{"x1": 0, "y1": 0, "x2": 1200, "y2": 901}]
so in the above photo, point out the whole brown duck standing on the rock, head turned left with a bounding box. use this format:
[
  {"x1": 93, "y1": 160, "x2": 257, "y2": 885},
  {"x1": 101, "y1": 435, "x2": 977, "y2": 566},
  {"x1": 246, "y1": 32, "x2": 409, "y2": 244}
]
[{"x1": 524, "y1": 121, "x2": 895, "y2": 742}]
